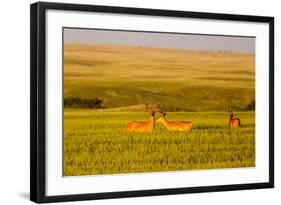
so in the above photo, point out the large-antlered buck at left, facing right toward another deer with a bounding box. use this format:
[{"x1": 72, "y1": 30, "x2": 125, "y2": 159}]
[{"x1": 127, "y1": 104, "x2": 160, "y2": 132}]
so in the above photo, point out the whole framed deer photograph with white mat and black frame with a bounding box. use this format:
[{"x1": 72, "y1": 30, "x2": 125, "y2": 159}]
[{"x1": 30, "y1": 2, "x2": 274, "y2": 203}]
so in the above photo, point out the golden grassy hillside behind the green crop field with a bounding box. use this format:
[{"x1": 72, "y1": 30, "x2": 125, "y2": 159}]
[{"x1": 64, "y1": 44, "x2": 255, "y2": 111}]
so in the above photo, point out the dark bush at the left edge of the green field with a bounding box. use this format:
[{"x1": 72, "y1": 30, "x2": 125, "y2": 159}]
[{"x1": 63, "y1": 97, "x2": 103, "y2": 109}]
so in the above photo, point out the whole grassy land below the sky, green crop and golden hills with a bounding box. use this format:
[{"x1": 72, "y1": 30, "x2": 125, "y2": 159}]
[{"x1": 63, "y1": 44, "x2": 255, "y2": 176}]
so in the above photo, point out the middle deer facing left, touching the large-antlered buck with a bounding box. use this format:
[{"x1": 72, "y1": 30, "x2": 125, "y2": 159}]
[{"x1": 156, "y1": 111, "x2": 192, "y2": 131}]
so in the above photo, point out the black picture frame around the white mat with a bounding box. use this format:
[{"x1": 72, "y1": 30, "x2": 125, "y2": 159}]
[{"x1": 30, "y1": 2, "x2": 274, "y2": 203}]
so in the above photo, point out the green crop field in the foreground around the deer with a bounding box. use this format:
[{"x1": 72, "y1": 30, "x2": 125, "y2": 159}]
[{"x1": 64, "y1": 109, "x2": 255, "y2": 176}]
